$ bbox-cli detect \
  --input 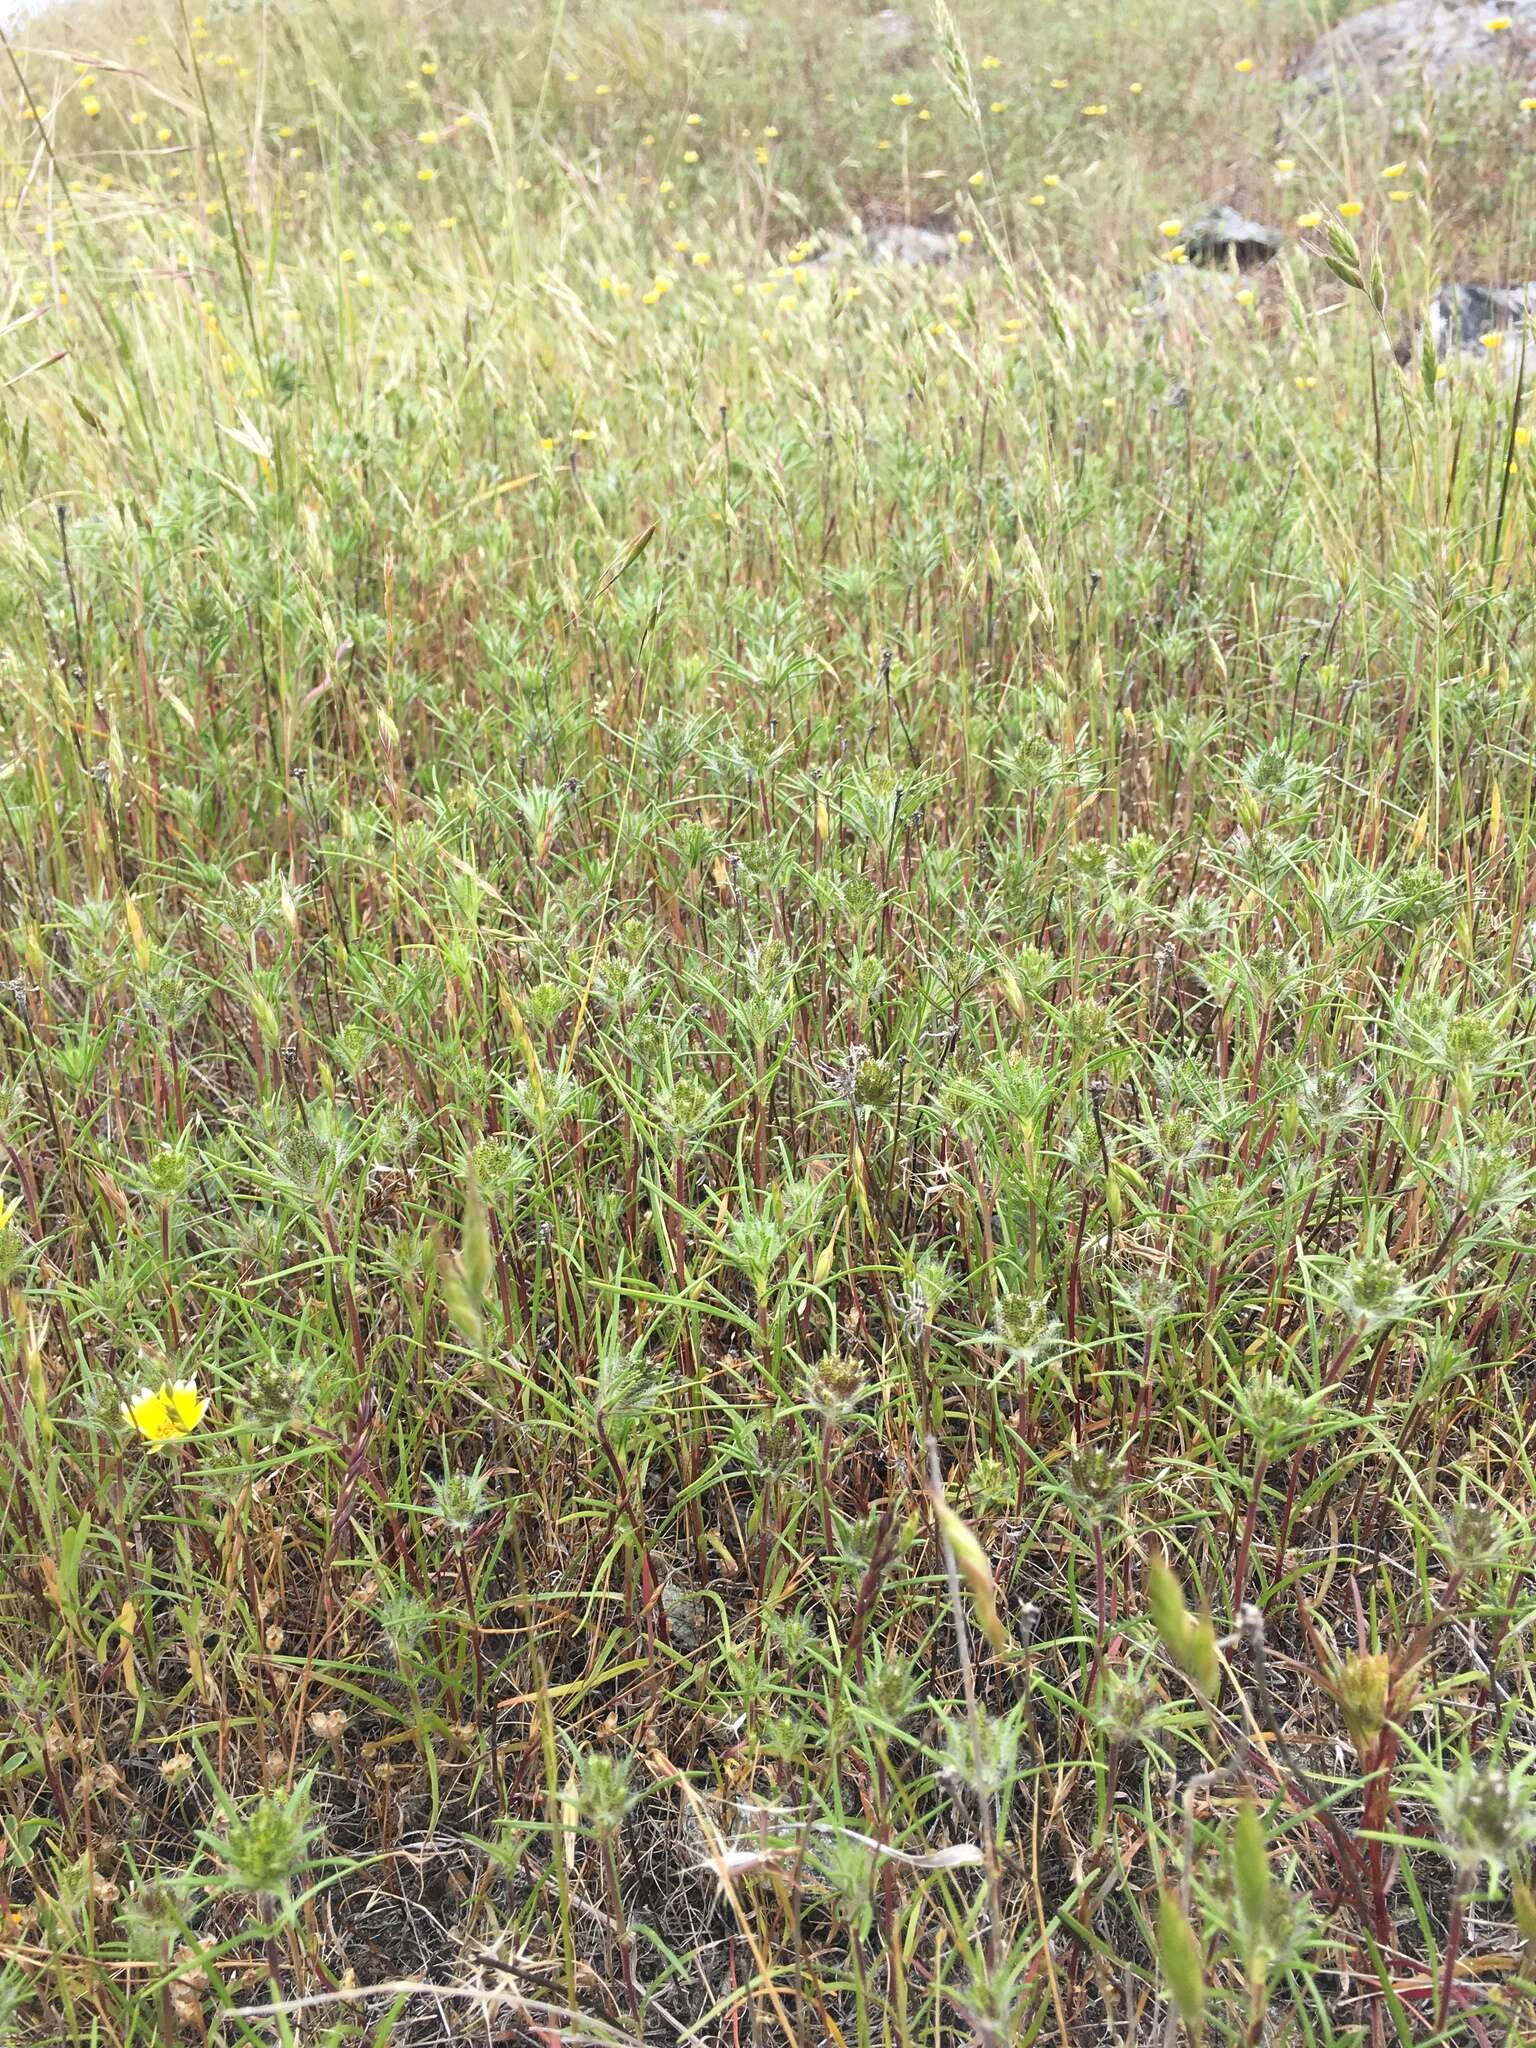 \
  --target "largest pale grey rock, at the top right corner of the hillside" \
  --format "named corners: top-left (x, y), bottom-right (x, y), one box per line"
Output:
top-left (1292, 0), bottom-right (1536, 96)
